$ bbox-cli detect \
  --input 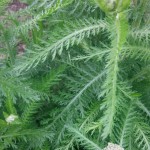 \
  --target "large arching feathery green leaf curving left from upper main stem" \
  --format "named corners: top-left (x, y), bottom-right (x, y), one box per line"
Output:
top-left (15, 19), bottom-right (107, 72)
